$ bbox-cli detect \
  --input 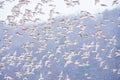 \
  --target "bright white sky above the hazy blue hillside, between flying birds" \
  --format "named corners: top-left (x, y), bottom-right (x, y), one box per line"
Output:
top-left (0, 0), bottom-right (119, 21)
